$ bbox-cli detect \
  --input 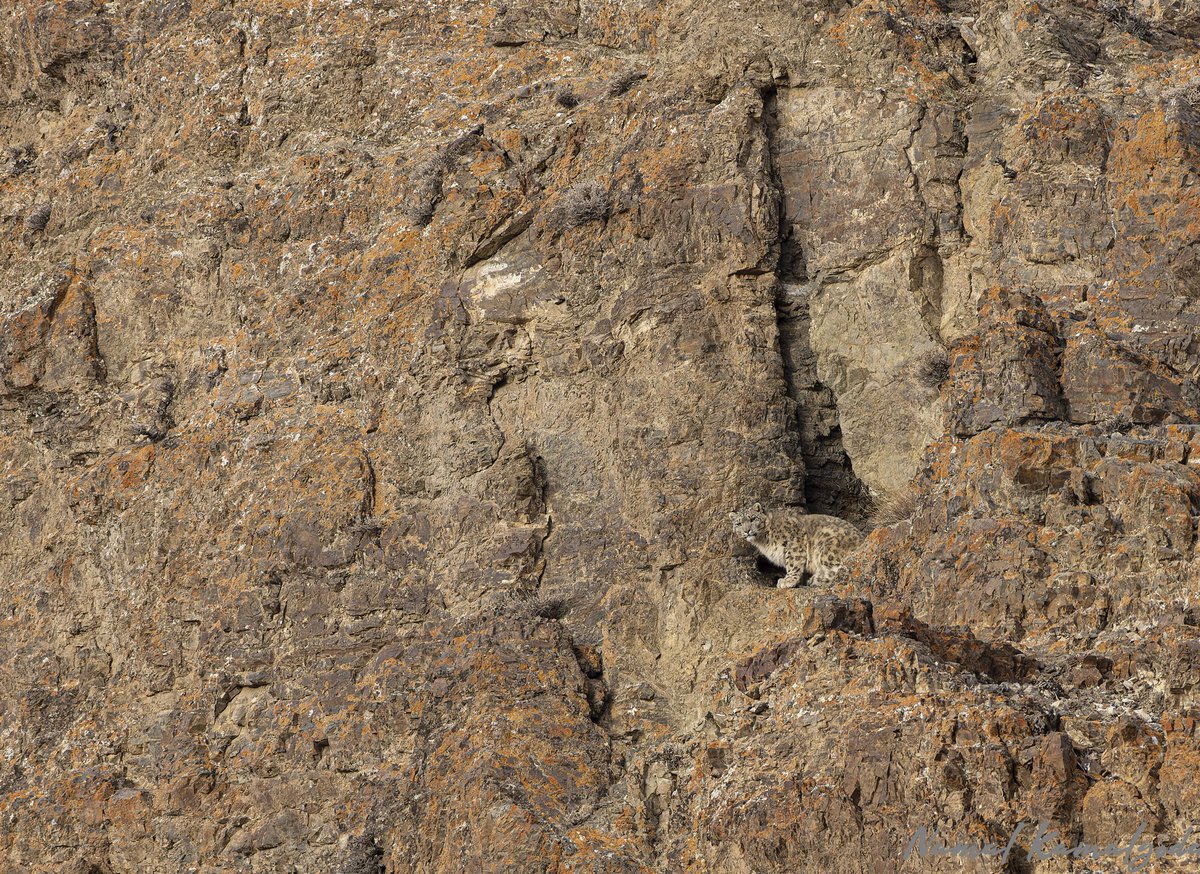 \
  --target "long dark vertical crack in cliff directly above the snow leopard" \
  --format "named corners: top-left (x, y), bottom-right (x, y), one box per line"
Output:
top-left (763, 90), bottom-right (870, 523)
